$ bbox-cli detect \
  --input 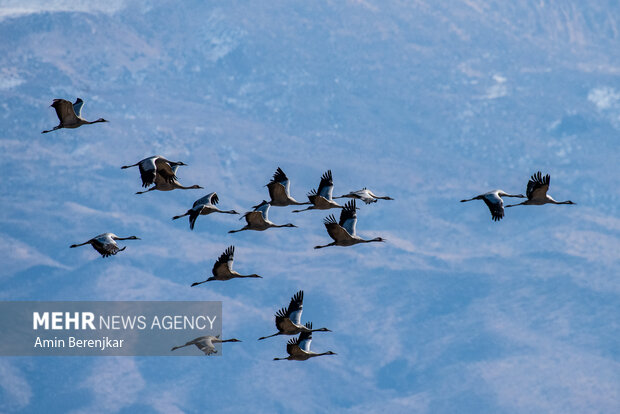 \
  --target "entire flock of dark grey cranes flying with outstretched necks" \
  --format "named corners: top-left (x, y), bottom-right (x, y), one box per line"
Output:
top-left (53, 98), bottom-right (575, 361)
